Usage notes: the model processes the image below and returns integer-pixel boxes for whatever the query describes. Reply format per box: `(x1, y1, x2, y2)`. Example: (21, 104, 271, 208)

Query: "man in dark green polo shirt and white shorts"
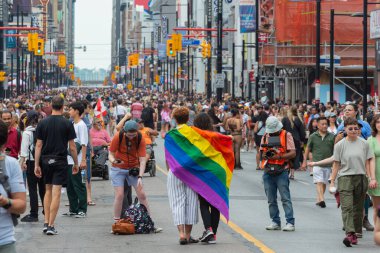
(302, 117, 335, 208)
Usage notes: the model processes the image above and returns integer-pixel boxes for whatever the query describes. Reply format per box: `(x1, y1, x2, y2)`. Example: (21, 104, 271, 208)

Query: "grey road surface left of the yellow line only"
(16, 171, 260, 253)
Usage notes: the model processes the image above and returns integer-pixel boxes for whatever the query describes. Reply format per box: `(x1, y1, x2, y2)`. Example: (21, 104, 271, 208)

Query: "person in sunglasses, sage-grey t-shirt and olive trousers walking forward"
(330, 117, 377, 247)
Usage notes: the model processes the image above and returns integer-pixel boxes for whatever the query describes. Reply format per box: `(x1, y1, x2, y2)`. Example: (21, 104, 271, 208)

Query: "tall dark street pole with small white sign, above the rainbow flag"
(216, 0, 224, 101)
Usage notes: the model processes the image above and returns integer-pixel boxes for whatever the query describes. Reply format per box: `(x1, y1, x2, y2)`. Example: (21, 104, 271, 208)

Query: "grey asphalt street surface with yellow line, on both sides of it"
(16, 139, 376, 253)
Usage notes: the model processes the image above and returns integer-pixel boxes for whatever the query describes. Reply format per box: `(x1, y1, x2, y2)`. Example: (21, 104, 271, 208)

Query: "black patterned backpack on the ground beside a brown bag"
(121, 197, 154, 234)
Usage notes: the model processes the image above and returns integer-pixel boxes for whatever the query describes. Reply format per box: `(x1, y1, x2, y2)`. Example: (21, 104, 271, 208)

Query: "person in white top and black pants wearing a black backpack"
(20, 111, 45, 222)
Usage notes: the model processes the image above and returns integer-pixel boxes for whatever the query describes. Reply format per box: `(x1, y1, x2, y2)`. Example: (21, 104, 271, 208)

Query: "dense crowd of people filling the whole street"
(0, 88, 380, 252)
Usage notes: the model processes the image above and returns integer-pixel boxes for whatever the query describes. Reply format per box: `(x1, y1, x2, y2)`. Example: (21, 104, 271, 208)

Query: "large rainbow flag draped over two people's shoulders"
(165, 125, 235, 220)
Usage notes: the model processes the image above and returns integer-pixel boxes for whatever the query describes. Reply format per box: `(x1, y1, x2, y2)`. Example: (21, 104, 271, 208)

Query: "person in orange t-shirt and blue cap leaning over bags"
(109, 120, 162, 233)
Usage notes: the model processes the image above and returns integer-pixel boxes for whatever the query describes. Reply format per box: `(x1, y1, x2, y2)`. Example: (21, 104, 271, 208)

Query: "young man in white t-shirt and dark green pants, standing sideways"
(63, 102, 88, 218)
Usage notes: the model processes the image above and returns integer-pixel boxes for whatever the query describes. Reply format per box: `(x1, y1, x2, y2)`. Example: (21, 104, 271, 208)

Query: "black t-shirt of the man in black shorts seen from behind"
(36, 115, 76, 157)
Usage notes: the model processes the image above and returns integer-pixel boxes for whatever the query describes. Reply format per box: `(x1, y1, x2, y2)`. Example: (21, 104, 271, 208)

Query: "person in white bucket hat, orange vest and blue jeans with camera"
(260, 116, 296, 231)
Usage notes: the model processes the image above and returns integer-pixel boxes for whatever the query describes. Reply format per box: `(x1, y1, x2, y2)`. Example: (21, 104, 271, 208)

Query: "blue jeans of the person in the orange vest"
(263, 171, 294, 225)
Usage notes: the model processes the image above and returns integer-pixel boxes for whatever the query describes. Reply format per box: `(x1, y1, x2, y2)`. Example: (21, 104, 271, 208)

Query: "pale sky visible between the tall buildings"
(75, 0, 112, 69)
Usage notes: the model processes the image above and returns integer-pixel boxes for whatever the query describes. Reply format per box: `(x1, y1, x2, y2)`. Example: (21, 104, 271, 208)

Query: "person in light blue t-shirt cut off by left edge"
(0, 121, 26, 253)
